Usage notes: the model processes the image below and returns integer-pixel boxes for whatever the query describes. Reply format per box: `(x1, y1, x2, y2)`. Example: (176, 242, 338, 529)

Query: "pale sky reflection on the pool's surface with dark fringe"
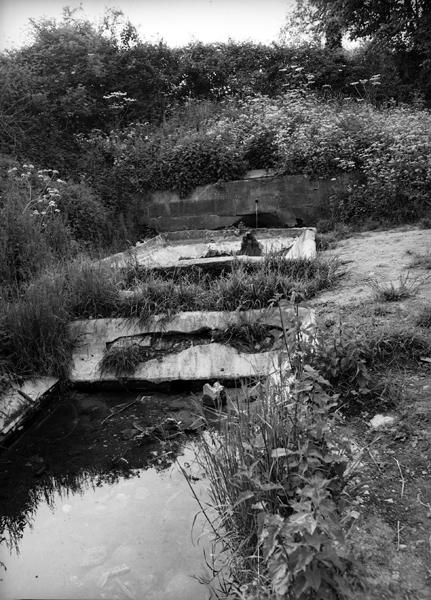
(0, 398, 213, 600)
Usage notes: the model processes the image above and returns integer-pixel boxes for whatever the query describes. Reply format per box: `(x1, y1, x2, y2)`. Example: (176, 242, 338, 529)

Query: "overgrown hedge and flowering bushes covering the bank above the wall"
(0, 6, 431, 237)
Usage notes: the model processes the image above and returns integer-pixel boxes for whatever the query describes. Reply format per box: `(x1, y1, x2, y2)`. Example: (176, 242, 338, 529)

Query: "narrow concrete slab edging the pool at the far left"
(0, 377, 58, 436)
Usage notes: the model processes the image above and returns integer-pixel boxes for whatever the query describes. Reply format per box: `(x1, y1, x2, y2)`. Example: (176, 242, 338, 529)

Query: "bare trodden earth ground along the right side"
(313, 227, 431, 600)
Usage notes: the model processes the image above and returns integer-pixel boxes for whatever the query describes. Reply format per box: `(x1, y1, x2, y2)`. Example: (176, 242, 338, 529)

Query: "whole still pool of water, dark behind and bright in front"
(0, 395, 213, 600)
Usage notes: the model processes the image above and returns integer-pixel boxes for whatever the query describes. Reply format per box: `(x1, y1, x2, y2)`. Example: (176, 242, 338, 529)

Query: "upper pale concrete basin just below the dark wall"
(101, 228, 316, 269)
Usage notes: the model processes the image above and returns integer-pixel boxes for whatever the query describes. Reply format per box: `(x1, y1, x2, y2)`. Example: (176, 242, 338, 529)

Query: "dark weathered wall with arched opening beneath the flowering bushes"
(142, 171, 350, 231)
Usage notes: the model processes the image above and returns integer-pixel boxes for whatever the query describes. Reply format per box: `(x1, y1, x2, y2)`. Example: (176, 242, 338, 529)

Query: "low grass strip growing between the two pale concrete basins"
(117, 256, 341, 319)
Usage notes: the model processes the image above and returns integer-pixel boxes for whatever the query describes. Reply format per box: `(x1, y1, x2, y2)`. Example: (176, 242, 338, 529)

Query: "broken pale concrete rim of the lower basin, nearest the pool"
(70, 308, 314, 384)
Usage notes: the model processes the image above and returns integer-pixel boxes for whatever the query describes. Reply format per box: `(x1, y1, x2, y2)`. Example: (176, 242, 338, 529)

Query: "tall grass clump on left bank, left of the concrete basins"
(0, 258, 119, 379)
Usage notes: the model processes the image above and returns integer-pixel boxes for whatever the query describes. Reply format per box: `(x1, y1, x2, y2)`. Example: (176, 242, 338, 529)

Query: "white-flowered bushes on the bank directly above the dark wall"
(76, 91, 431, 223)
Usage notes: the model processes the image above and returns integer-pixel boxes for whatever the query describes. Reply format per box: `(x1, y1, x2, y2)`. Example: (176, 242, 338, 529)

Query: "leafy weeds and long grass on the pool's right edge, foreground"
(189, 312, 354, 600)
